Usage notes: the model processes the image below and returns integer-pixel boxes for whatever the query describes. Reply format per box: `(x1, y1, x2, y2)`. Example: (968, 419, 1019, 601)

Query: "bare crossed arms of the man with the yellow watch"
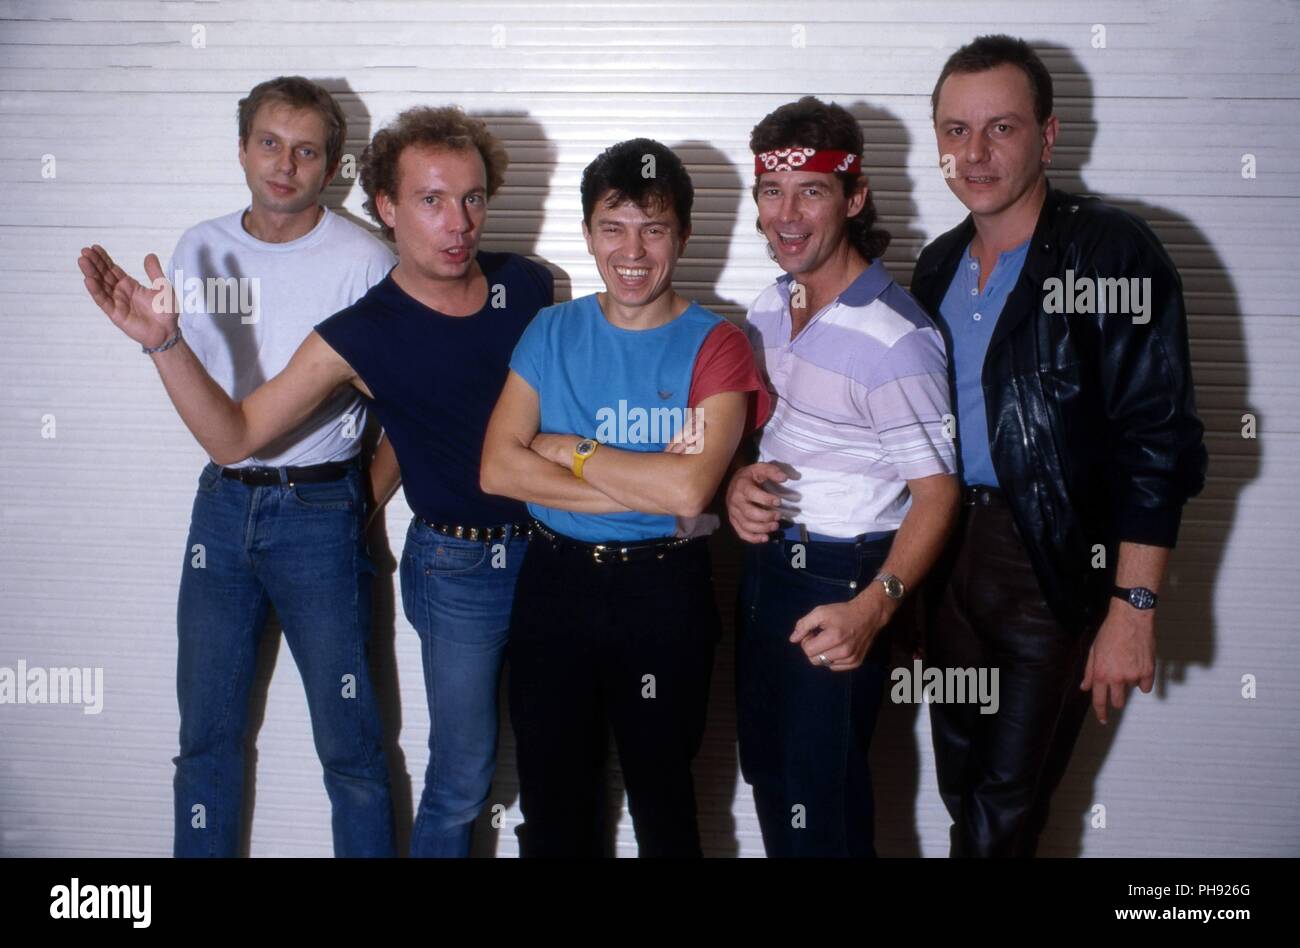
(480, 371, 748, 518)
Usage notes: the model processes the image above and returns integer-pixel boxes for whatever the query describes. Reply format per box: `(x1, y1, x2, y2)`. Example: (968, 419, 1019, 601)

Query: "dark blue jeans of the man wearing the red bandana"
(736, 534, 893, 857)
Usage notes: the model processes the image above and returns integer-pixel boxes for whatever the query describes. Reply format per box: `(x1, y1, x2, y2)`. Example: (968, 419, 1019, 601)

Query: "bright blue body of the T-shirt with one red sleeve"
(510, 294, 723, 542)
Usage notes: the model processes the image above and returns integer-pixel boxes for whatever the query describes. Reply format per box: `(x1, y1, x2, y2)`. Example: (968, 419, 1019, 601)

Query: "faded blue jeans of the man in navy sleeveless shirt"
(402, 518, 528, 858)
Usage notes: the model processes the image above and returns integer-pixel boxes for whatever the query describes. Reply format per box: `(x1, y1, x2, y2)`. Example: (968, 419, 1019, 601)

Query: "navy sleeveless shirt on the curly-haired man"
(316, 251, 555, 527)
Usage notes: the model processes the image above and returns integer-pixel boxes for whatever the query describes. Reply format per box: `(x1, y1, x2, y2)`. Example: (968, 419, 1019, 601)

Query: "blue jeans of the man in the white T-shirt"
(174, 463, 397, 856)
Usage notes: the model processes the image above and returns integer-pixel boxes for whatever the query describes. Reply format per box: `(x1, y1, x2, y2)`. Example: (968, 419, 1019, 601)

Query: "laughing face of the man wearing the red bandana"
(755, 172, 867, 276)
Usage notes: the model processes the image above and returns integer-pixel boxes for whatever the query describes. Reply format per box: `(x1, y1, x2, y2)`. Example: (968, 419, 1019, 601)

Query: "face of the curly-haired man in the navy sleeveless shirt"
(374, 144, 488, 280)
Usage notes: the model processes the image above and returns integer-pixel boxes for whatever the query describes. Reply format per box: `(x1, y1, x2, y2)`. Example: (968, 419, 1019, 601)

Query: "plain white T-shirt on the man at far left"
(165, 208, 397, 467)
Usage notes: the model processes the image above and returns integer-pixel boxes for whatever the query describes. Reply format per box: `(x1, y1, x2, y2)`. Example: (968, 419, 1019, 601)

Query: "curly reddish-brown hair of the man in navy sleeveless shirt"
(360, 105, 510, 241)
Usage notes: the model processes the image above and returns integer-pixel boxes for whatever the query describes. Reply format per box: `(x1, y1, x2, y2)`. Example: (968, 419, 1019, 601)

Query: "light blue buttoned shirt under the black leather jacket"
(939, 241, 1030, 488)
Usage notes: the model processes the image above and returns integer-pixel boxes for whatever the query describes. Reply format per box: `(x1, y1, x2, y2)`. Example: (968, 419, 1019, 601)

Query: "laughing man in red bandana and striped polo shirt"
(727, 96, 957, 857)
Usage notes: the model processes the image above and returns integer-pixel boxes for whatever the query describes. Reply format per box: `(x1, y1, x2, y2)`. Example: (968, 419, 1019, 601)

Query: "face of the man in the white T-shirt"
(239, 101, 334, 215)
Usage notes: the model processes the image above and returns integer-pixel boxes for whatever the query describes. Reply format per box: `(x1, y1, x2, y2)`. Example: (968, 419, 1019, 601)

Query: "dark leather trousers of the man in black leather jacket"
(926, 501, 1096, 857)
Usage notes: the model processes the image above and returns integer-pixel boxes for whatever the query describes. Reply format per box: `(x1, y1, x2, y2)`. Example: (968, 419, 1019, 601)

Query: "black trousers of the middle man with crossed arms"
(507, 536, 722, 857)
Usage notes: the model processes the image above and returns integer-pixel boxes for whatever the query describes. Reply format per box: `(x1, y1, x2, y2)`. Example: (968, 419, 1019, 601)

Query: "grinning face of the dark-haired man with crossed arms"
(582, 191, 690, 311)
